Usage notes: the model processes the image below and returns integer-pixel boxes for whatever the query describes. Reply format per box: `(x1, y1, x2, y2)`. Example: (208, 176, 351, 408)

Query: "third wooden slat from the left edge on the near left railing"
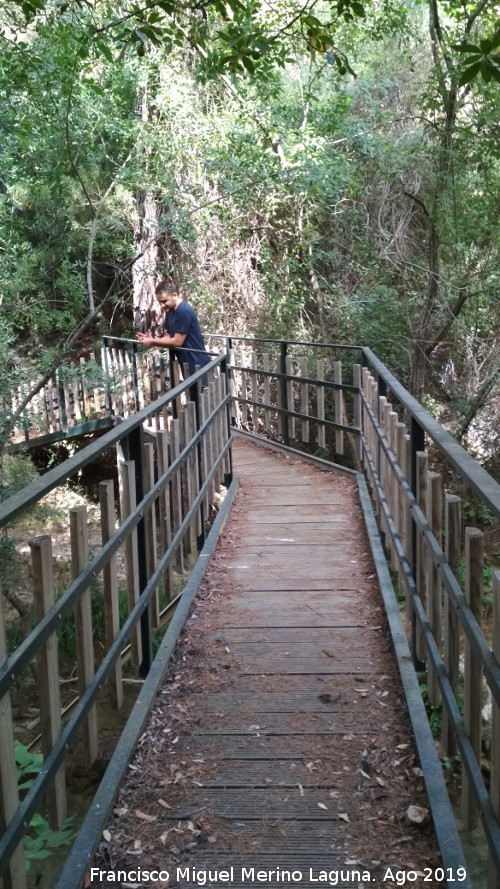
(69, 506, 99, 764)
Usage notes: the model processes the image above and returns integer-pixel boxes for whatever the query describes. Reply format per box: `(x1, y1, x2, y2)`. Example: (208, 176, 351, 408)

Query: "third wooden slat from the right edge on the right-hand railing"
(442, 494, 462, 756)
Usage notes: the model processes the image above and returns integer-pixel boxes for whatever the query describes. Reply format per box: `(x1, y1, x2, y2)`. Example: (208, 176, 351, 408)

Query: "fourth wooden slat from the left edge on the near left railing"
(99, 480, 123, 710)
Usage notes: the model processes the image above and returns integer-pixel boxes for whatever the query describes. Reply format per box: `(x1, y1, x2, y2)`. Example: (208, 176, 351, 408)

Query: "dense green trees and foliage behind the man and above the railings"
(0, 0, 500, 458)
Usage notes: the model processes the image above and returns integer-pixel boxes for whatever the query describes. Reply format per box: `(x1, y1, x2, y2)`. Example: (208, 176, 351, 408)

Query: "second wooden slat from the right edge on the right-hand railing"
(462, 528, 484, 830)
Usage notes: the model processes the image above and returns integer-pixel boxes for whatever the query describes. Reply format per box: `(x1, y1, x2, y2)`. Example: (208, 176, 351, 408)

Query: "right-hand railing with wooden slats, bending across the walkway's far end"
(221, 338, 500, 889)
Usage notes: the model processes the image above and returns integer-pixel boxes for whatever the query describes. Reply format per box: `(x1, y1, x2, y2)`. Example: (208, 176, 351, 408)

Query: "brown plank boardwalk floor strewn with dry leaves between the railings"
(99, 440, 441, 889)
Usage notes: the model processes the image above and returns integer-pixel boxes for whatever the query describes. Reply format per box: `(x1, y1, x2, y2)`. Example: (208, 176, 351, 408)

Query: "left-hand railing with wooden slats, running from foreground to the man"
(0, 355, 231, 889)
